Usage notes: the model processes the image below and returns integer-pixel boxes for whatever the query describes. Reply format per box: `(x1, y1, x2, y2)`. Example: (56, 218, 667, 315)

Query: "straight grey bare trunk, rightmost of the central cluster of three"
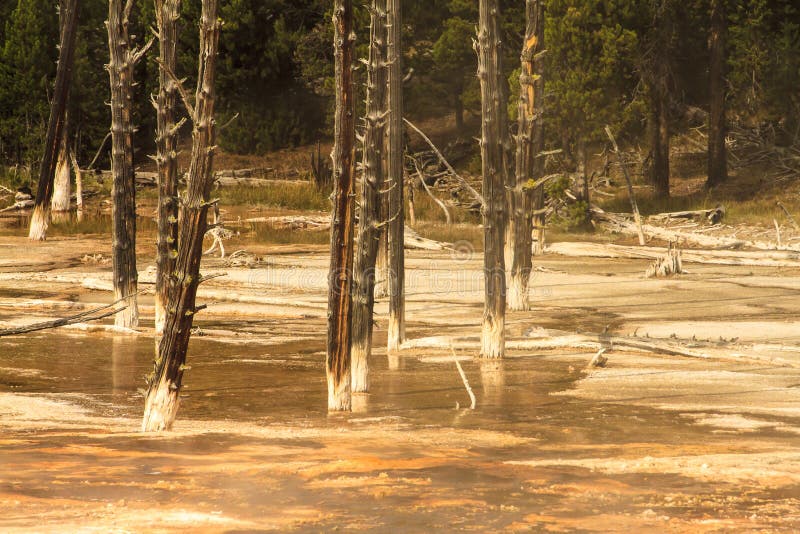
(386, 0, 406, 351)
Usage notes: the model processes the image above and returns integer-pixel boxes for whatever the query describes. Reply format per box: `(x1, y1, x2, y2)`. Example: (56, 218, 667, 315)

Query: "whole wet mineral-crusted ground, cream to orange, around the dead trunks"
(0, 216, 800, 532)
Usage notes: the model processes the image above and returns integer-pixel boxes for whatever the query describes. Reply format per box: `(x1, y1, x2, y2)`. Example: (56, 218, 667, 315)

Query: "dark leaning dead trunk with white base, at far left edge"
(28, 0, 78, 241)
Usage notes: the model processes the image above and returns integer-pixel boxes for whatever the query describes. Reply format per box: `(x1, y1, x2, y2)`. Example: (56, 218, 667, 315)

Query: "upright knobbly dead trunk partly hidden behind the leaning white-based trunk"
(155, 0, 181, 339)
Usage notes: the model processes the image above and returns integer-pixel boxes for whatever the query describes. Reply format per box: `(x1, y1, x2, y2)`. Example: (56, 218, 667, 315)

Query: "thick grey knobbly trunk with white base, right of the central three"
(477, 0, 507, 358)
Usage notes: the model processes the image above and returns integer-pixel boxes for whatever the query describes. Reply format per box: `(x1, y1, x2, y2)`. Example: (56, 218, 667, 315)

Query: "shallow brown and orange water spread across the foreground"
(0, 330, 800, 531)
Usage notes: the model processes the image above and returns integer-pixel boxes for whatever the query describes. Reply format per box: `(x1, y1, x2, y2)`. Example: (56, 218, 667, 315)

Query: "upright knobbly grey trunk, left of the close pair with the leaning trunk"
(107, 0, 139, 328)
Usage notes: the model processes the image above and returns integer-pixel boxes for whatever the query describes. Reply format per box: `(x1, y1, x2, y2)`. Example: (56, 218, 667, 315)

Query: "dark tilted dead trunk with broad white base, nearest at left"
(142, 0, 220, 432)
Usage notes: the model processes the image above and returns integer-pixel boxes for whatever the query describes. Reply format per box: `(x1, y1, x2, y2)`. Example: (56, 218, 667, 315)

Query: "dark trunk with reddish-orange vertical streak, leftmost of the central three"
(325, 0, 356, 411)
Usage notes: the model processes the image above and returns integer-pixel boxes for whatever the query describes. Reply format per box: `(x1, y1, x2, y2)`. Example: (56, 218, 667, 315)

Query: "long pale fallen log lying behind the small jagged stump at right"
(545, 242, 800, 267)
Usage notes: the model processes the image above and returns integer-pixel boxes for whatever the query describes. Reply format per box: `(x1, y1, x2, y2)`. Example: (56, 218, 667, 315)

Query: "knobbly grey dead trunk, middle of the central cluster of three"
(350, 0, 386, 393)
